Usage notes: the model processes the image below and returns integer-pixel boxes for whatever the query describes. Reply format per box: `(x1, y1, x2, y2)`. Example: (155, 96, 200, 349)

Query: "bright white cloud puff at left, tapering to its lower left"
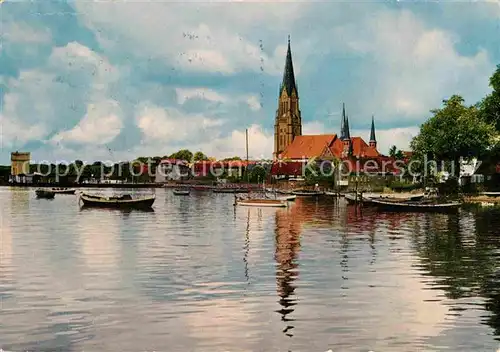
(51, 100, 123, 145)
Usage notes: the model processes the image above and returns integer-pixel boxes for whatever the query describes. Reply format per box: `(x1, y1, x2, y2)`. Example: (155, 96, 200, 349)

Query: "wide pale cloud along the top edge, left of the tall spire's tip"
(75, 0, 303, 75)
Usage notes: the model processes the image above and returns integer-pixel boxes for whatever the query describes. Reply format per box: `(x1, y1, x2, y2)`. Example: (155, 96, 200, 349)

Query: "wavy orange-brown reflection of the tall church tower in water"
(275, 206, 302, 337)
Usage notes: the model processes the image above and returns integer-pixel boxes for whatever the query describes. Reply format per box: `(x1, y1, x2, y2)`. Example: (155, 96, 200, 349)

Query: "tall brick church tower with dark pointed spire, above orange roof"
(273, 36, 302, 160)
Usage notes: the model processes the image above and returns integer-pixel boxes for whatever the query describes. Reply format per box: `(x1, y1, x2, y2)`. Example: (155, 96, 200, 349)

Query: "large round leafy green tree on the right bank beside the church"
(411, 95, 495, 177)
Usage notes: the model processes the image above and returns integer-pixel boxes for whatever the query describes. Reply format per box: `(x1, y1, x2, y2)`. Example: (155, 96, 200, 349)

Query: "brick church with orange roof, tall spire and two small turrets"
(273, 37, 384, 162)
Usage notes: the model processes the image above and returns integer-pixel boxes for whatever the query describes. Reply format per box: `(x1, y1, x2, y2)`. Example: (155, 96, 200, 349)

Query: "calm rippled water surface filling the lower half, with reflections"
(0, 188, 500, 352)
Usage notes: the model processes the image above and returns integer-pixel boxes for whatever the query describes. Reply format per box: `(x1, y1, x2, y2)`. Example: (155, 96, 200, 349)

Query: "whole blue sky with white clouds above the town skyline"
(0, 0, 500, 164)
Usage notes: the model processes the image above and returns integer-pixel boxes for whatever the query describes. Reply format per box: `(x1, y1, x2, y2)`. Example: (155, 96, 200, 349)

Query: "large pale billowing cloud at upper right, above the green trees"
(334, 10, 494, 116)
